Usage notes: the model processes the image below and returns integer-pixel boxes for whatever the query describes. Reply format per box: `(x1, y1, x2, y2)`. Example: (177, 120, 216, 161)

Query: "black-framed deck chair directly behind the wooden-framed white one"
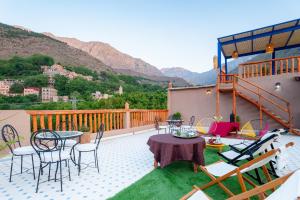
(218, 132, 280, 183)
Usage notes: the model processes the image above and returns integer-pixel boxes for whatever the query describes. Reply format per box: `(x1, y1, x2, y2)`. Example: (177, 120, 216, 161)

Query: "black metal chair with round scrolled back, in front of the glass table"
(30, 129, 71, 193)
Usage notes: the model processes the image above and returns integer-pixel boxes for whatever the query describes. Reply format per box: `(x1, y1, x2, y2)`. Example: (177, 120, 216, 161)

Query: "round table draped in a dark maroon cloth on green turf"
(147, 134, 205, 172)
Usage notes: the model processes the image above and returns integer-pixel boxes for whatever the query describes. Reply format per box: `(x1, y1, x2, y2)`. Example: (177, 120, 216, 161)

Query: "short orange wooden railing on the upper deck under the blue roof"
(239, 56, 300, 78)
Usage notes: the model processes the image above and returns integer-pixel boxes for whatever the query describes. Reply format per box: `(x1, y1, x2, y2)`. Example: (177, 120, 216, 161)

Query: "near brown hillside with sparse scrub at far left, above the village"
(0, 23, 112, 71)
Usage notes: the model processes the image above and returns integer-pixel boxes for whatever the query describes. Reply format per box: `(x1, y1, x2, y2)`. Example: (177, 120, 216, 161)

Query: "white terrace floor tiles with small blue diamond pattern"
(0, 131, 300, 200)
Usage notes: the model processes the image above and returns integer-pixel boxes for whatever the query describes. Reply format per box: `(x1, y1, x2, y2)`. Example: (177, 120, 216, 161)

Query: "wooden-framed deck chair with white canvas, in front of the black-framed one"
(181, 142, 294, 200)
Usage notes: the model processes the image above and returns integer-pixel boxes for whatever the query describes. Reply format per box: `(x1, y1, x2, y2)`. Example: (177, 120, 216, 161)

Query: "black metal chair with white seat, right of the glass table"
(71, 123, 104, 176)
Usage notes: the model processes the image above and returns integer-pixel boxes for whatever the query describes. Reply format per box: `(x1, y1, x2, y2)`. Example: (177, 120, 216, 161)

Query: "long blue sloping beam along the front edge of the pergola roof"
(221, 25, 300, 45)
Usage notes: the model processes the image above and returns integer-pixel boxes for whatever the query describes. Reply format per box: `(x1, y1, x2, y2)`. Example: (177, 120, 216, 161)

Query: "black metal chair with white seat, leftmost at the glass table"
(1, 124, 35, 182)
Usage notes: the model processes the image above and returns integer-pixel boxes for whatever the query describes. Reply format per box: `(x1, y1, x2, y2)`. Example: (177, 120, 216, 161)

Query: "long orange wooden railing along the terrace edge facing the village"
(27, 109, 168, 132)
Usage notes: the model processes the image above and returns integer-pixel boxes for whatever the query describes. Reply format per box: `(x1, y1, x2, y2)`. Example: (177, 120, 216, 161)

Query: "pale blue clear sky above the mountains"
(0, 0, 300, 72)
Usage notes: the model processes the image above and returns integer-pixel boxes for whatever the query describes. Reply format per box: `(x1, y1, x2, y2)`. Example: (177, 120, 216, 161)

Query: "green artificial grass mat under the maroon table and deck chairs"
(110, 148, 270, 200)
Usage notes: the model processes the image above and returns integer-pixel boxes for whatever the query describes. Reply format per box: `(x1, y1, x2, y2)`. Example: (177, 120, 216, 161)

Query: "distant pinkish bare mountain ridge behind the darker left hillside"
(44, 33, 163, 76)
